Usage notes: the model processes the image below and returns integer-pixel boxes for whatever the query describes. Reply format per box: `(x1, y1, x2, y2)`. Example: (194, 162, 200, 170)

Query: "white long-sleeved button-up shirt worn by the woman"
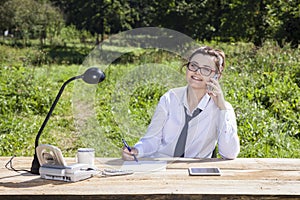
(134, 86, 240, 159)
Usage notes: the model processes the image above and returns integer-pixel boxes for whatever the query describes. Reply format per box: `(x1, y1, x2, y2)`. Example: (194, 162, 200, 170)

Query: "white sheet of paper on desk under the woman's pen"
(121, 160, 167, 172)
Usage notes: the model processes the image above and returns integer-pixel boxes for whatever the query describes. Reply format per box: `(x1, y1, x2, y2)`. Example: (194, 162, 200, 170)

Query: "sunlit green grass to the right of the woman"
(222, 43, 300, 157)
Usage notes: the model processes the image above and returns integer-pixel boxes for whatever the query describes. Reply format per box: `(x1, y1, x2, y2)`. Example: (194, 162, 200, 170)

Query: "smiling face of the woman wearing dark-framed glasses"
(186, 53, 216, 90)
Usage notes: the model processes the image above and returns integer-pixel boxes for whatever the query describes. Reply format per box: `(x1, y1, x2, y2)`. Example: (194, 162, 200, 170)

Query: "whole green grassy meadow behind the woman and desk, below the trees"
(0, 42, 300, 158)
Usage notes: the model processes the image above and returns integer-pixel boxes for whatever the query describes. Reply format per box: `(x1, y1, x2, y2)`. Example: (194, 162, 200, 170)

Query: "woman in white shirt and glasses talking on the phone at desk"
(122, 47, 240, 160)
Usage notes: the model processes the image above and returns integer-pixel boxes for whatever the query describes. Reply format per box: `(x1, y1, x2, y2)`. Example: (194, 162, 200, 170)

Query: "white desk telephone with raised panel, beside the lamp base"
(36, 144, 99, 182)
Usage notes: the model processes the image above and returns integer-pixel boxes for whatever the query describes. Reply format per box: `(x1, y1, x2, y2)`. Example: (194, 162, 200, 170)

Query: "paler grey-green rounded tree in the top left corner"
(0, 0, 63, 45)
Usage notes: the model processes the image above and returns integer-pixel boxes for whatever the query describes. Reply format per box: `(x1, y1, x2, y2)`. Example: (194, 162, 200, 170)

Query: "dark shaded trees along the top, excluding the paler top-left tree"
(40, 0, 300, 46)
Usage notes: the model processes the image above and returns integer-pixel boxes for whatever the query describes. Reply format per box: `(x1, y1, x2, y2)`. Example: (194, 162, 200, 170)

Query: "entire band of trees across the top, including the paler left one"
(0, 0, 300, 48)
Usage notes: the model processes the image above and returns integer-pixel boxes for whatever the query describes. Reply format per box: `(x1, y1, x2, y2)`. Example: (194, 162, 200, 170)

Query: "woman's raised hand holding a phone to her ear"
(206, 78, 226, 110)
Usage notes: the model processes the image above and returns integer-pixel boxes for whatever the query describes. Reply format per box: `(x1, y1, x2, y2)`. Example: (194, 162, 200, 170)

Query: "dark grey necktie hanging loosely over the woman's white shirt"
(174, 107, 202, 157)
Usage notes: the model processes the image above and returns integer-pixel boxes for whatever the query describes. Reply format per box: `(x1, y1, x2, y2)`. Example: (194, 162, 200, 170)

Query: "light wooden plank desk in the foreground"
(0, 157, 300, 199)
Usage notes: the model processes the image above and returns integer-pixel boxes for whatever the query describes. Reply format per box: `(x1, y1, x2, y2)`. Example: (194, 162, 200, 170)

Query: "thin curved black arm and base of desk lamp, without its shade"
(31, 75, 82, 174)
